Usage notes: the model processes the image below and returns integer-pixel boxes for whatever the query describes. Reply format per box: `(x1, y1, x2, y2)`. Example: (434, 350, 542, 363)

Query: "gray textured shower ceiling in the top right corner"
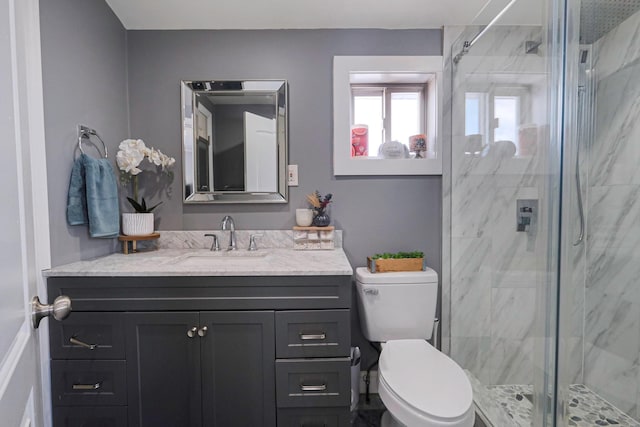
(580, 0, 640, 44)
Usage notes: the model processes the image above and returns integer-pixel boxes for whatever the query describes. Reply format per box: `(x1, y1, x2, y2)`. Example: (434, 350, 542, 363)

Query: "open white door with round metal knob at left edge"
(0, 0, 50, 427)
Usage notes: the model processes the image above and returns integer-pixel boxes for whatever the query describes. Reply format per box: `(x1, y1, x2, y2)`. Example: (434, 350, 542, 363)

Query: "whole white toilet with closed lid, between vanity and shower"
(356, 267, 475, 427)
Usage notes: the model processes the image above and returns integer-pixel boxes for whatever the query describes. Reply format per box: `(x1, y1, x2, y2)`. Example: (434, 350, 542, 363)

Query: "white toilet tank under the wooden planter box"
(356, 267, 438, 342)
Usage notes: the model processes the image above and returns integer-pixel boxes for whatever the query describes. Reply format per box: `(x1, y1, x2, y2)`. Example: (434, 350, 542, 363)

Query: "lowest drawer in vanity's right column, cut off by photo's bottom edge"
(278, 407, 351, 427)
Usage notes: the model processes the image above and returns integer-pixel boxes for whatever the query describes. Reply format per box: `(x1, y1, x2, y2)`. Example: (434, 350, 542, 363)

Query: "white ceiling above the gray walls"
(105, 0, 544, 30)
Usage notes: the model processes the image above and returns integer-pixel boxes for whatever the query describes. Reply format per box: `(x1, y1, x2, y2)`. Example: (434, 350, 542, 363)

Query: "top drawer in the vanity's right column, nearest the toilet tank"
(276, 310, 351, 358)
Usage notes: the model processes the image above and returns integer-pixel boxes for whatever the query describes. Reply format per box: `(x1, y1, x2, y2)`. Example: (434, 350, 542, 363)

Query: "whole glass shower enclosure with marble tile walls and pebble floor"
(442, 0, 640, 427)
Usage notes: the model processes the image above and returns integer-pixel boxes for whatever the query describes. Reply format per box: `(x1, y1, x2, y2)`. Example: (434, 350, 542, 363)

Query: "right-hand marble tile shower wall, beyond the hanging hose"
(584, 8, 640, 419)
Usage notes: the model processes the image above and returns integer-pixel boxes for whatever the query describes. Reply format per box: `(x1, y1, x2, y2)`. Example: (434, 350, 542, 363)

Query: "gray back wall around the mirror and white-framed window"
(128, 30, 442, 366)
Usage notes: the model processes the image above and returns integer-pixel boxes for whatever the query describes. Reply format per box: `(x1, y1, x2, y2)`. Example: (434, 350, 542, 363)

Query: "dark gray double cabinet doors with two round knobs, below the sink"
(125, 311, 275, 427)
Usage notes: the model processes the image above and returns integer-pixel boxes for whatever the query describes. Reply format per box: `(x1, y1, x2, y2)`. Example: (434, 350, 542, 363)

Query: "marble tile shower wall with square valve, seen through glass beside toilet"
(443, 27, 547, 384)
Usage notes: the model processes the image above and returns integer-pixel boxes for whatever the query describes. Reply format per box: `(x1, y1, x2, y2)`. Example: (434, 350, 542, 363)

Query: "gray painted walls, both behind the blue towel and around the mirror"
(41, 17, 442, 366)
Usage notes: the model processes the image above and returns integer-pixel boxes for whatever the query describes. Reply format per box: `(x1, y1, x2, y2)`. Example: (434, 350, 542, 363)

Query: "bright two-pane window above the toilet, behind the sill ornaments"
(351, 84, 426, 157)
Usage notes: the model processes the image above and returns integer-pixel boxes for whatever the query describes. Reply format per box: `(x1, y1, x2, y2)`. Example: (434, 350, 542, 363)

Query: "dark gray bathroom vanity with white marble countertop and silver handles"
(47, 244, 352, 427)
